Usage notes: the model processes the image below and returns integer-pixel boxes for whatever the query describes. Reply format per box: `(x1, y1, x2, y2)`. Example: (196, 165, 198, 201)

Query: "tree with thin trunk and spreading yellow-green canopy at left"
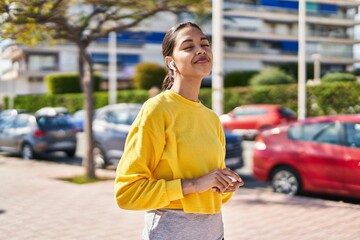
(0, 0, 209, 178)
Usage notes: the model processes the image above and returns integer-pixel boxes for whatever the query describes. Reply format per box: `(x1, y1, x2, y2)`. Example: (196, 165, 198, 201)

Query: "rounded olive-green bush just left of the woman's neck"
(133, 63, 166, 90)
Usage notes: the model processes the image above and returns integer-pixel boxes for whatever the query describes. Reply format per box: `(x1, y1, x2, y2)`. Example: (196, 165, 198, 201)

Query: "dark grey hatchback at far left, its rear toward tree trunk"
(0, 109, 77, 159)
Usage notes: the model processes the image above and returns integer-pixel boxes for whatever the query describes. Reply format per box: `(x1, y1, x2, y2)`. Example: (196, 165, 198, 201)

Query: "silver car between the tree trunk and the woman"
(93, 103, 142, 168)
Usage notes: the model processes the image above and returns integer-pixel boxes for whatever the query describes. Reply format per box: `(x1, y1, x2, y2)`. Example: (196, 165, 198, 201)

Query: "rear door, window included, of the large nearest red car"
(301, 122, 345, 191)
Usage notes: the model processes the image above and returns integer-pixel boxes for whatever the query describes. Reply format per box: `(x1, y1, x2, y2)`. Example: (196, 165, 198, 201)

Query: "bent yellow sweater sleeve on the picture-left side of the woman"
(115, 107, 183, 210)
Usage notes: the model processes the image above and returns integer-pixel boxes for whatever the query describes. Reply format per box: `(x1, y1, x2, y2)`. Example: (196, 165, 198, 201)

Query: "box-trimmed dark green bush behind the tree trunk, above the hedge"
(45, 73, 101, 94)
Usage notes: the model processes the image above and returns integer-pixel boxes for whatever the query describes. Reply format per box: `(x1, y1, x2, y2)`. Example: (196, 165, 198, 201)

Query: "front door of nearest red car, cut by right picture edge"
(343, 122, 360, 196)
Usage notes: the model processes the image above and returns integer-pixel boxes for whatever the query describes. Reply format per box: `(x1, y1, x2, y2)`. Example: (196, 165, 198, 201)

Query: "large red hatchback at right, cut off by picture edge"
(253, 115, 360, 198)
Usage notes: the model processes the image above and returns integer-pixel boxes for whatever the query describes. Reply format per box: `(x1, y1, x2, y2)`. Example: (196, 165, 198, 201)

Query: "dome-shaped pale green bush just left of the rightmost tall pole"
(250, 67, 296, 86)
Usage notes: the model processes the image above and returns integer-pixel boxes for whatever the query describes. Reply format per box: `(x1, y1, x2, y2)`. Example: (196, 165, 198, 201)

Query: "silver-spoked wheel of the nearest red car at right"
(271, 167, 301, 196)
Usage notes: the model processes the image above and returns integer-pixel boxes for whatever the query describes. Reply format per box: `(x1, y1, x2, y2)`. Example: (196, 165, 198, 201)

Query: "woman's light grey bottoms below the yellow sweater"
(142, 209, 224, 240)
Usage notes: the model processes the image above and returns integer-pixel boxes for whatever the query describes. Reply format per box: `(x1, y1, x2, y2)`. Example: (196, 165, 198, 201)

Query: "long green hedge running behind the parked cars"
(4, 82, 360, 116)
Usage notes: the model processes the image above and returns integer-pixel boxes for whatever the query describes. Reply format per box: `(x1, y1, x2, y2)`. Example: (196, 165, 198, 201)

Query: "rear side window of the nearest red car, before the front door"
(288, 122, 340, 144)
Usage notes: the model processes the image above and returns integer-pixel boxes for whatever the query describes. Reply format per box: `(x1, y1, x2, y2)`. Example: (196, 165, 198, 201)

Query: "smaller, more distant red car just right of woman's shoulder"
(220, 104, 296, 139)
